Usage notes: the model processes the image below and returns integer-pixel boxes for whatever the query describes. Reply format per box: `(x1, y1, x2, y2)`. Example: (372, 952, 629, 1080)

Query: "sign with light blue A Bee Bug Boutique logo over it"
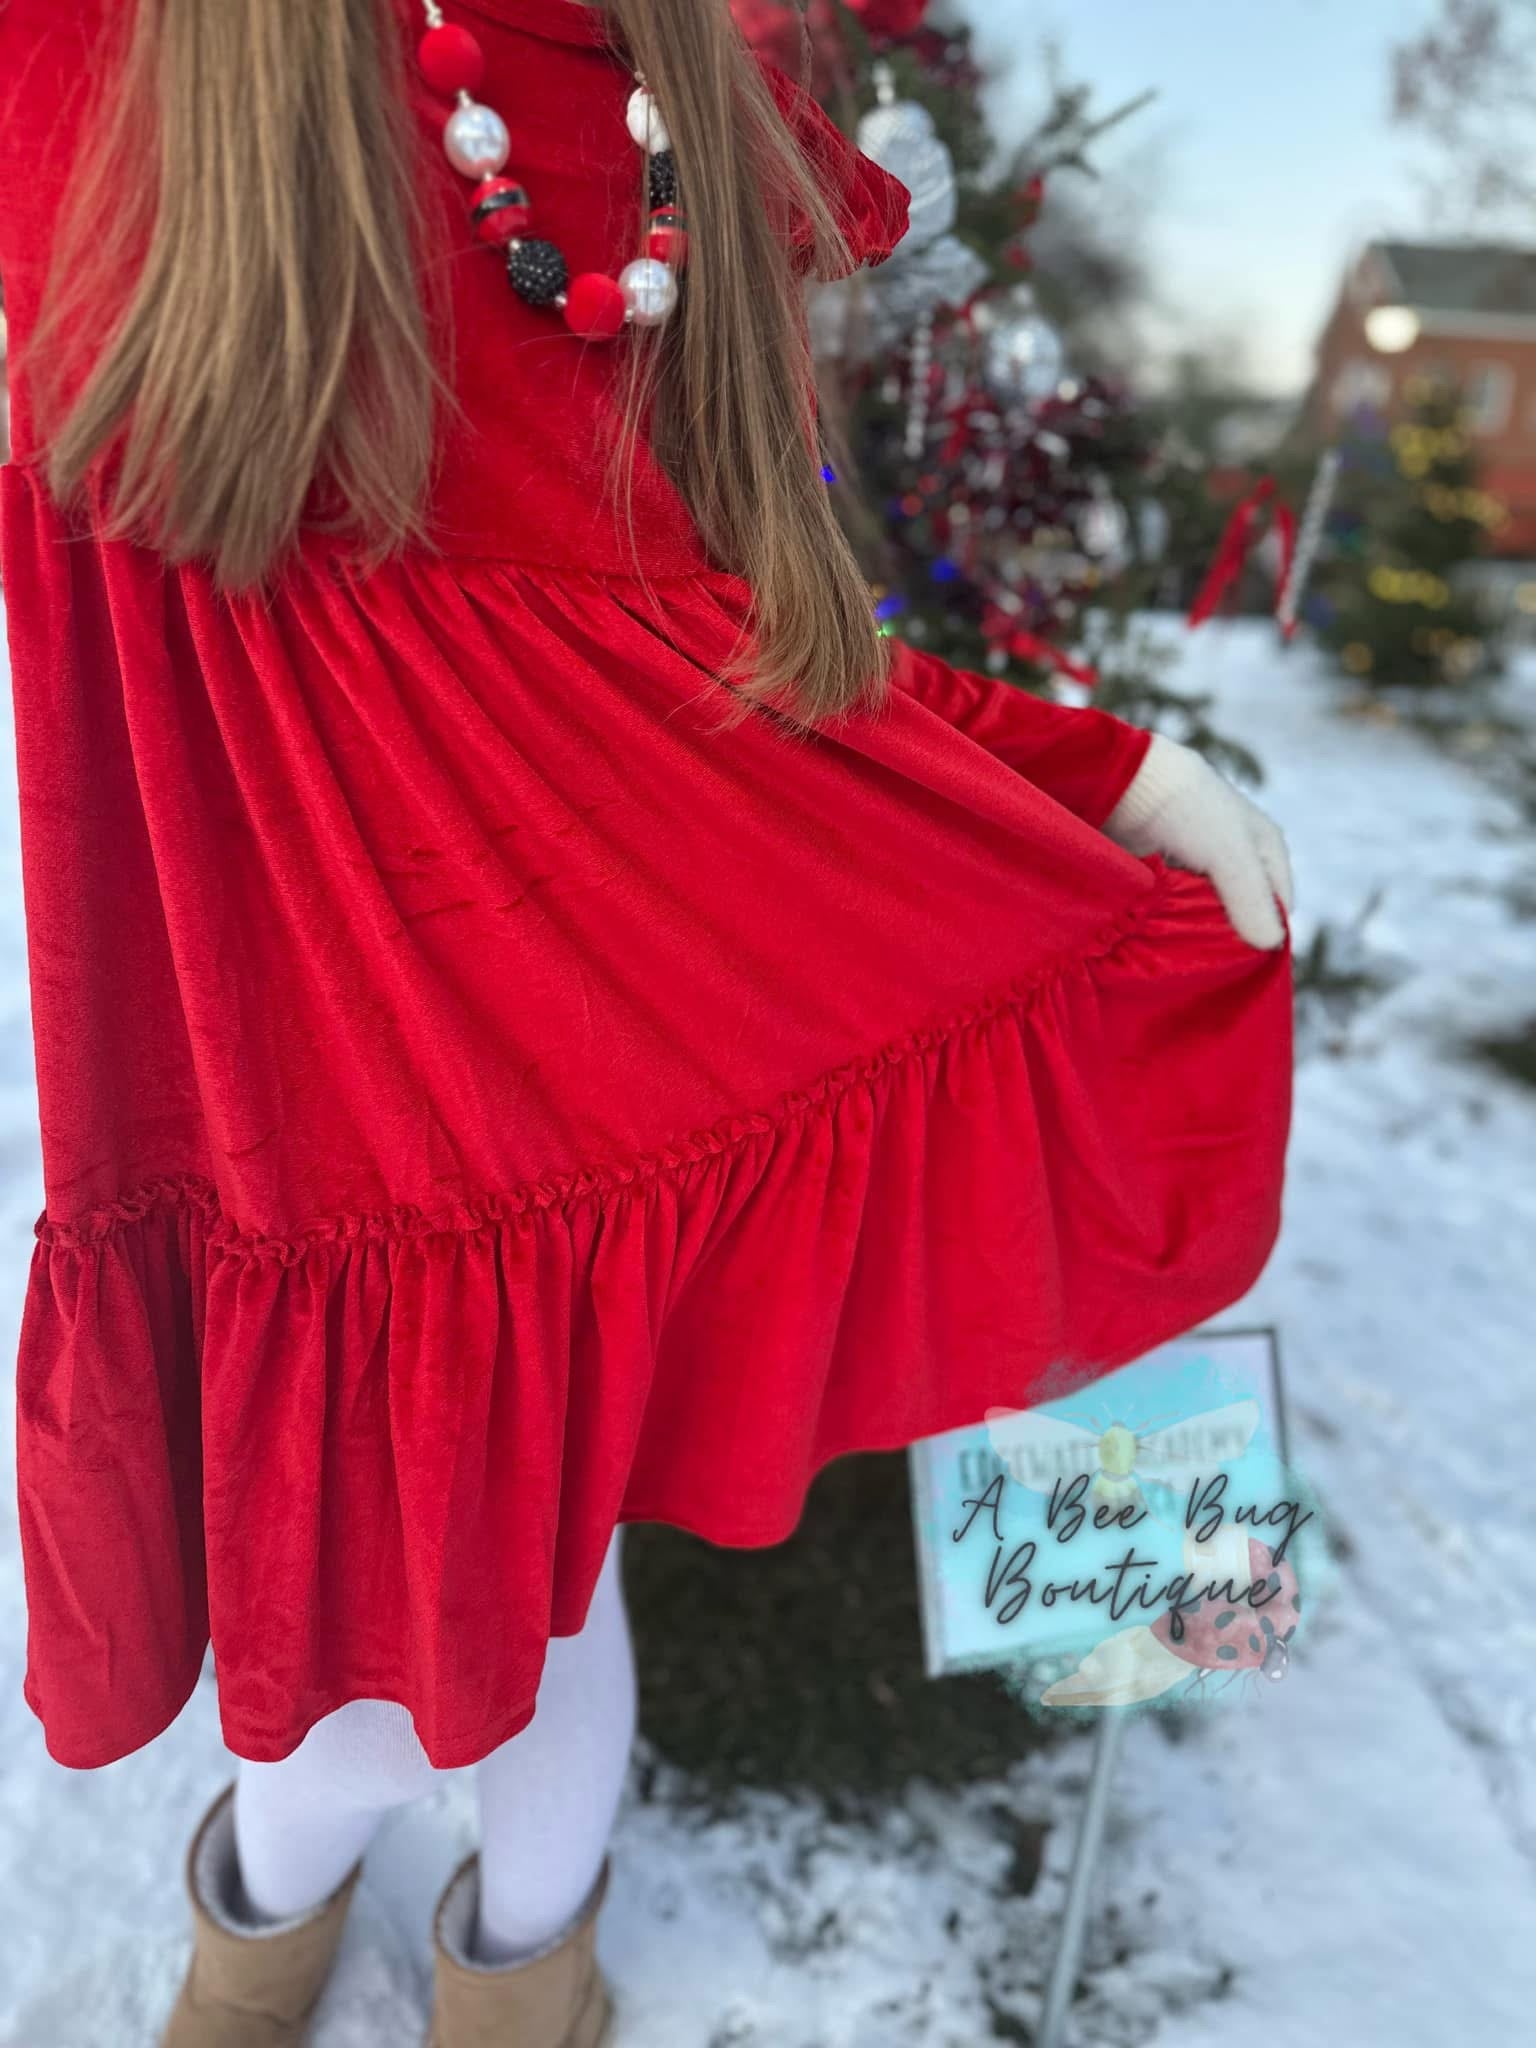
(911, 1329, 1315, 1708)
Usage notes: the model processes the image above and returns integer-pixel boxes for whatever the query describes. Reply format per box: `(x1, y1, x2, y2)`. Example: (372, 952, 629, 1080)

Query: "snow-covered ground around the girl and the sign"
(0, 627, 1536, 2048)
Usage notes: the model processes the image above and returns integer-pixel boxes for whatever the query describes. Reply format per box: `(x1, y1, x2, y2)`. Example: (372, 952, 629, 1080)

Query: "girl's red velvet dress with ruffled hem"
(0, 0, 1290, 1765)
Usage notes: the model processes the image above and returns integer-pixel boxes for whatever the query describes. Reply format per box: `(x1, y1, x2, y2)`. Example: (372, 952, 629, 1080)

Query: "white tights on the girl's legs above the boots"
(236, 1532, 635, 1962)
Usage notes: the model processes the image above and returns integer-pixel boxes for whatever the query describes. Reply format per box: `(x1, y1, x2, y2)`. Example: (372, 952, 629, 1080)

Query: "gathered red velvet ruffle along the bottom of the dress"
(20, 870, 1288, 1767)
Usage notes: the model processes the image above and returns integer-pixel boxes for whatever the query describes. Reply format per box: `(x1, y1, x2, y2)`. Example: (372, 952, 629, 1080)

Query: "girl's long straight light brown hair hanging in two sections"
(31, 0, 885, 723)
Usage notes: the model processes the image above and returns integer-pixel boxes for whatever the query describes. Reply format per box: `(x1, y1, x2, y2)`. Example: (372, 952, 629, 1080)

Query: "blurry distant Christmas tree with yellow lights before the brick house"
(1315, 379, 1505, 688)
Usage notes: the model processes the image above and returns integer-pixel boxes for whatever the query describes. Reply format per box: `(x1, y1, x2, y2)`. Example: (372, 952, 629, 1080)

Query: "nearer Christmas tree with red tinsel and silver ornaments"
(737, 0, 1253, 772)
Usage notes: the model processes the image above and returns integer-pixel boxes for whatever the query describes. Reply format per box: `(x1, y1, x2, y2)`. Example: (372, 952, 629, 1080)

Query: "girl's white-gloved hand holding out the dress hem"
(1104, 733, 1296, 952)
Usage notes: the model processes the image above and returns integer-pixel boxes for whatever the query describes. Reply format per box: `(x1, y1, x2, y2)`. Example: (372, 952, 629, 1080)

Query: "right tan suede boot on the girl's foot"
(428, 1855, 612, 2048)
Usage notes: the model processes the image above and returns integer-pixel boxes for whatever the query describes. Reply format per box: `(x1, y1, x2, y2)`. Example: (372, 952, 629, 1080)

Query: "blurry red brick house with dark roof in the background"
(1307, 242, 1536, 561)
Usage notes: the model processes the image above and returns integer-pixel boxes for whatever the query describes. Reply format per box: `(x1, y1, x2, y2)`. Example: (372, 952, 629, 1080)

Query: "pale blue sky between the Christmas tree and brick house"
(961, 0, 1444, 389)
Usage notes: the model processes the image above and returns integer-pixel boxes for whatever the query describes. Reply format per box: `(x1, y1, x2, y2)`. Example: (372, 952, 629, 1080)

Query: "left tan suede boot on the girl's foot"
(162, 1786, 362, 2048)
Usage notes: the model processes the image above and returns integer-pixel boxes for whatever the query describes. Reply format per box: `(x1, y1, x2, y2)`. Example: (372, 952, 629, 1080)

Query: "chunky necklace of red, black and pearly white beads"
(416, 0, 688, 342)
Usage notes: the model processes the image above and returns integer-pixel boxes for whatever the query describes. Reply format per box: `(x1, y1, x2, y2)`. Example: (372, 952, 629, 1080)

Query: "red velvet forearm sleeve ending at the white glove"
(891, 643, 1151, 827)
